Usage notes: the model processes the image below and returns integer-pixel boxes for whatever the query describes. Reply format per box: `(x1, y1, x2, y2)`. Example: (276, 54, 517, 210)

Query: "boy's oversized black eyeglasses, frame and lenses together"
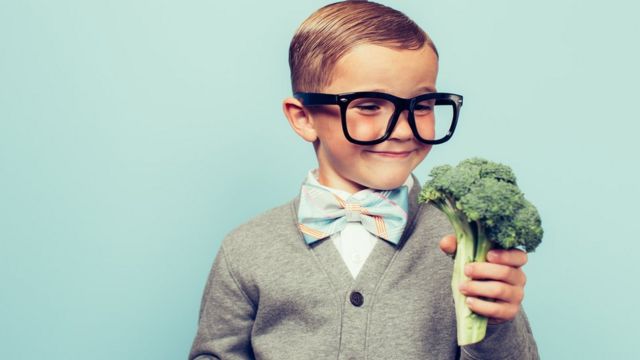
(293, 91, 462, 145)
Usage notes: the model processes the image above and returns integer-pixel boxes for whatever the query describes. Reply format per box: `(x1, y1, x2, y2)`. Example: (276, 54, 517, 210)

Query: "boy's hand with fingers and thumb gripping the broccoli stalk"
(440, 235, 527, 324)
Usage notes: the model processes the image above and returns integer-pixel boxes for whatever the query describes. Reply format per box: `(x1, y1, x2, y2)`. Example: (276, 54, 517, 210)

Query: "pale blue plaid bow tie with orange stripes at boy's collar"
(298, 181, 409, 245)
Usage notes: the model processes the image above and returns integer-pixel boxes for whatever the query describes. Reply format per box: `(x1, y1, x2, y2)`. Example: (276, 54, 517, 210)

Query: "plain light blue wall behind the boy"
(0, 0, 640, 359)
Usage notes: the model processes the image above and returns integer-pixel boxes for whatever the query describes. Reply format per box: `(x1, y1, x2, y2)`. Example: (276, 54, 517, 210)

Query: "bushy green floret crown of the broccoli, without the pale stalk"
(418, 158, 543, 251)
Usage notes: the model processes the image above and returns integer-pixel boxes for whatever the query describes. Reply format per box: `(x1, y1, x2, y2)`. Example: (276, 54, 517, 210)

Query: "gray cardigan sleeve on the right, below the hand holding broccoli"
(460, 309, 540, 360)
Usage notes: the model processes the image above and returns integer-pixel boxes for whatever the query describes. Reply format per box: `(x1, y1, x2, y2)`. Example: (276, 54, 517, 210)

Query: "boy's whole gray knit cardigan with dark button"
(189, 181, 538, 360)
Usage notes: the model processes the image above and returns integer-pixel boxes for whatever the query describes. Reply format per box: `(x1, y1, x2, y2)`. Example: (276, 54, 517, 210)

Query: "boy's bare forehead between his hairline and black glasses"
(324, 44, 438, 97)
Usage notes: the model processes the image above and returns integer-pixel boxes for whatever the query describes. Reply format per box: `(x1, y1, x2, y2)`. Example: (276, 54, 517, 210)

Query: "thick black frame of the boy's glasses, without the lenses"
(293, 91, 462, 145)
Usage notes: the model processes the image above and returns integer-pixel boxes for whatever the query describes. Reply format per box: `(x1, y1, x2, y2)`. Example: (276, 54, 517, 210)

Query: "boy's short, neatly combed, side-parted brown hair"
(289, 0, 438, 92)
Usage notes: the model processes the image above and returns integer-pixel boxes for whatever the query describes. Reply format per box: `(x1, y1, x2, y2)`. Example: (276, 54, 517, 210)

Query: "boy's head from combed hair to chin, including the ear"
(283, 1, 461, 193)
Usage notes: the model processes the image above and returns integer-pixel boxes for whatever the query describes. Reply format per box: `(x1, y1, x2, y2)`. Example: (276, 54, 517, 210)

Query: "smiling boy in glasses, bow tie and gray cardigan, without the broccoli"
(189, 1, 538, 360)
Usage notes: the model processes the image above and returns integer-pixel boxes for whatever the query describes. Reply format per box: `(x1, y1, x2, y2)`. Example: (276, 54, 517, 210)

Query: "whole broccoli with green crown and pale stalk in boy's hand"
(418, 158, 543, 346)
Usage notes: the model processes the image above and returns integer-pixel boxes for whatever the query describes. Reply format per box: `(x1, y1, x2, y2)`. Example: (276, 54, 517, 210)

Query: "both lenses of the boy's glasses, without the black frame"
(346, 98, 453, 141)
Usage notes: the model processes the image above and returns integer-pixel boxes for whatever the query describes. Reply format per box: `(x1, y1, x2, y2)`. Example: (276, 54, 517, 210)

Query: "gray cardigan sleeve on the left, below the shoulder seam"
(189, 244, 256, 360)
